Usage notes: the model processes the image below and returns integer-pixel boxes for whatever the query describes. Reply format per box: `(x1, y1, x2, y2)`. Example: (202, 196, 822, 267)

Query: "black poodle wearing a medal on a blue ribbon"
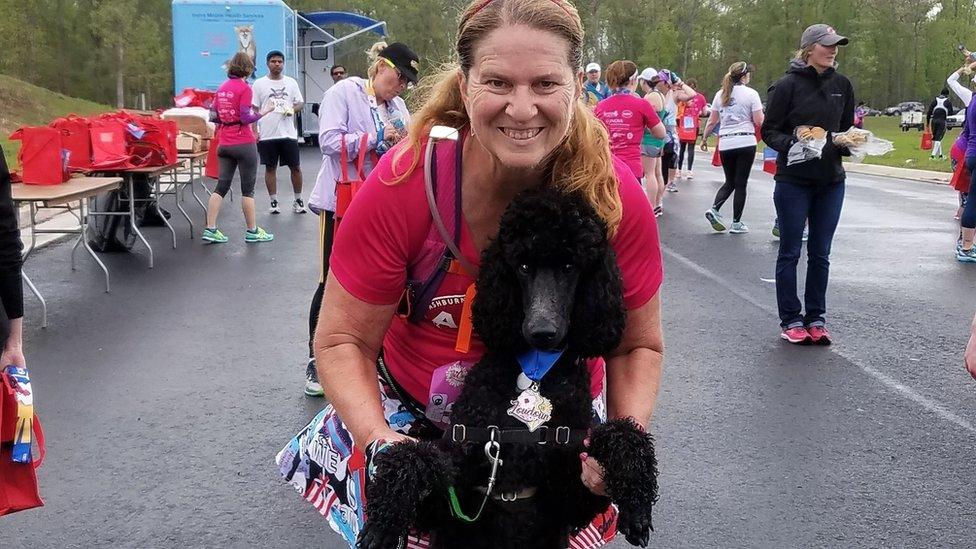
(358, 189, 657, 549)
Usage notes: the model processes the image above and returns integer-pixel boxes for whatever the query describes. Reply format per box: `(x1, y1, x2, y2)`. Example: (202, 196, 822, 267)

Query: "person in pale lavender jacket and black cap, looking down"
(305, 42, 420, 396)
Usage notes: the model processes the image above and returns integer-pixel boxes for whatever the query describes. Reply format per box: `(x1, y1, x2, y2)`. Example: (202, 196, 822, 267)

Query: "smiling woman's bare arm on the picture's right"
(607, 291, 664, 429)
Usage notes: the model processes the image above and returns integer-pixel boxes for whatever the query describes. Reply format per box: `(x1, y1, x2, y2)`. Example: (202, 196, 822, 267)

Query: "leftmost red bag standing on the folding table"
(10, 126, 71, 185)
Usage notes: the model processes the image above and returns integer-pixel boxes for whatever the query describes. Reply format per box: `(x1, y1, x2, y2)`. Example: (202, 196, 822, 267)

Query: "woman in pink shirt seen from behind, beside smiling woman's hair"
(593, 61, 666, 181)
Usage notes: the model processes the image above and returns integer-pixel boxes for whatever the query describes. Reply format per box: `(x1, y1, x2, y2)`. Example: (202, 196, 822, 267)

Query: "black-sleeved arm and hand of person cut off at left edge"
(0, 149, 26, 369)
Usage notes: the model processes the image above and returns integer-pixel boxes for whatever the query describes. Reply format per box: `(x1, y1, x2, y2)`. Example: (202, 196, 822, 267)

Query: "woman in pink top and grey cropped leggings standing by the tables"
(201, 52, 274, 243)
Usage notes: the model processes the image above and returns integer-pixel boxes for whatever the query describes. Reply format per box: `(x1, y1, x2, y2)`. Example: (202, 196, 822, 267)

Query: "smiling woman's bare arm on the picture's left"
(313, 273, 407, 448)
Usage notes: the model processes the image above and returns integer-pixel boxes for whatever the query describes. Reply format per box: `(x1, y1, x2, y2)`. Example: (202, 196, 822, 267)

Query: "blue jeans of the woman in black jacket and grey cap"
(773, 181, 844, 328)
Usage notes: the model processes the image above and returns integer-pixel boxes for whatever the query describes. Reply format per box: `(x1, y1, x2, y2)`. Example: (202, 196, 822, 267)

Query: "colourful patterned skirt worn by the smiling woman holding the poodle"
(275, 382, 617, 549)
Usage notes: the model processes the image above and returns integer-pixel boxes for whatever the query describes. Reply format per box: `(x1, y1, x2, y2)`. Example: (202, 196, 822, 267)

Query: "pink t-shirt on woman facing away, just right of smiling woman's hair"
(593, 93, 661, 179)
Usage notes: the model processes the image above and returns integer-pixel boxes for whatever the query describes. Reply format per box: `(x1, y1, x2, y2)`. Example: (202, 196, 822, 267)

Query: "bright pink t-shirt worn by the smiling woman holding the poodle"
(330, 139, 663, 408)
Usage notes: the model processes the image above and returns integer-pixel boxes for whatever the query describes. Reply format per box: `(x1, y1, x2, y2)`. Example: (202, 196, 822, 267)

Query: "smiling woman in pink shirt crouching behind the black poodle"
(278, 0, 663, 547)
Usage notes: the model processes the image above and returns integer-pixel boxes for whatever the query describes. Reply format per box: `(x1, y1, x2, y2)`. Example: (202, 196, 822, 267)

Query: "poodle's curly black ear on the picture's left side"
(471, 239, 525, 351)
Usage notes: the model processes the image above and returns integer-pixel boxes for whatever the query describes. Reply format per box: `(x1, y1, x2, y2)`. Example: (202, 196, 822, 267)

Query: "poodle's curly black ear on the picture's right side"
(568, 240, 627, 357)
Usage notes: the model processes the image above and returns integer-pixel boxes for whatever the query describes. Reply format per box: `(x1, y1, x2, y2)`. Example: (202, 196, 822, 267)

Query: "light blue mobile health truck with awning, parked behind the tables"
(173, 0, 386, 143)
